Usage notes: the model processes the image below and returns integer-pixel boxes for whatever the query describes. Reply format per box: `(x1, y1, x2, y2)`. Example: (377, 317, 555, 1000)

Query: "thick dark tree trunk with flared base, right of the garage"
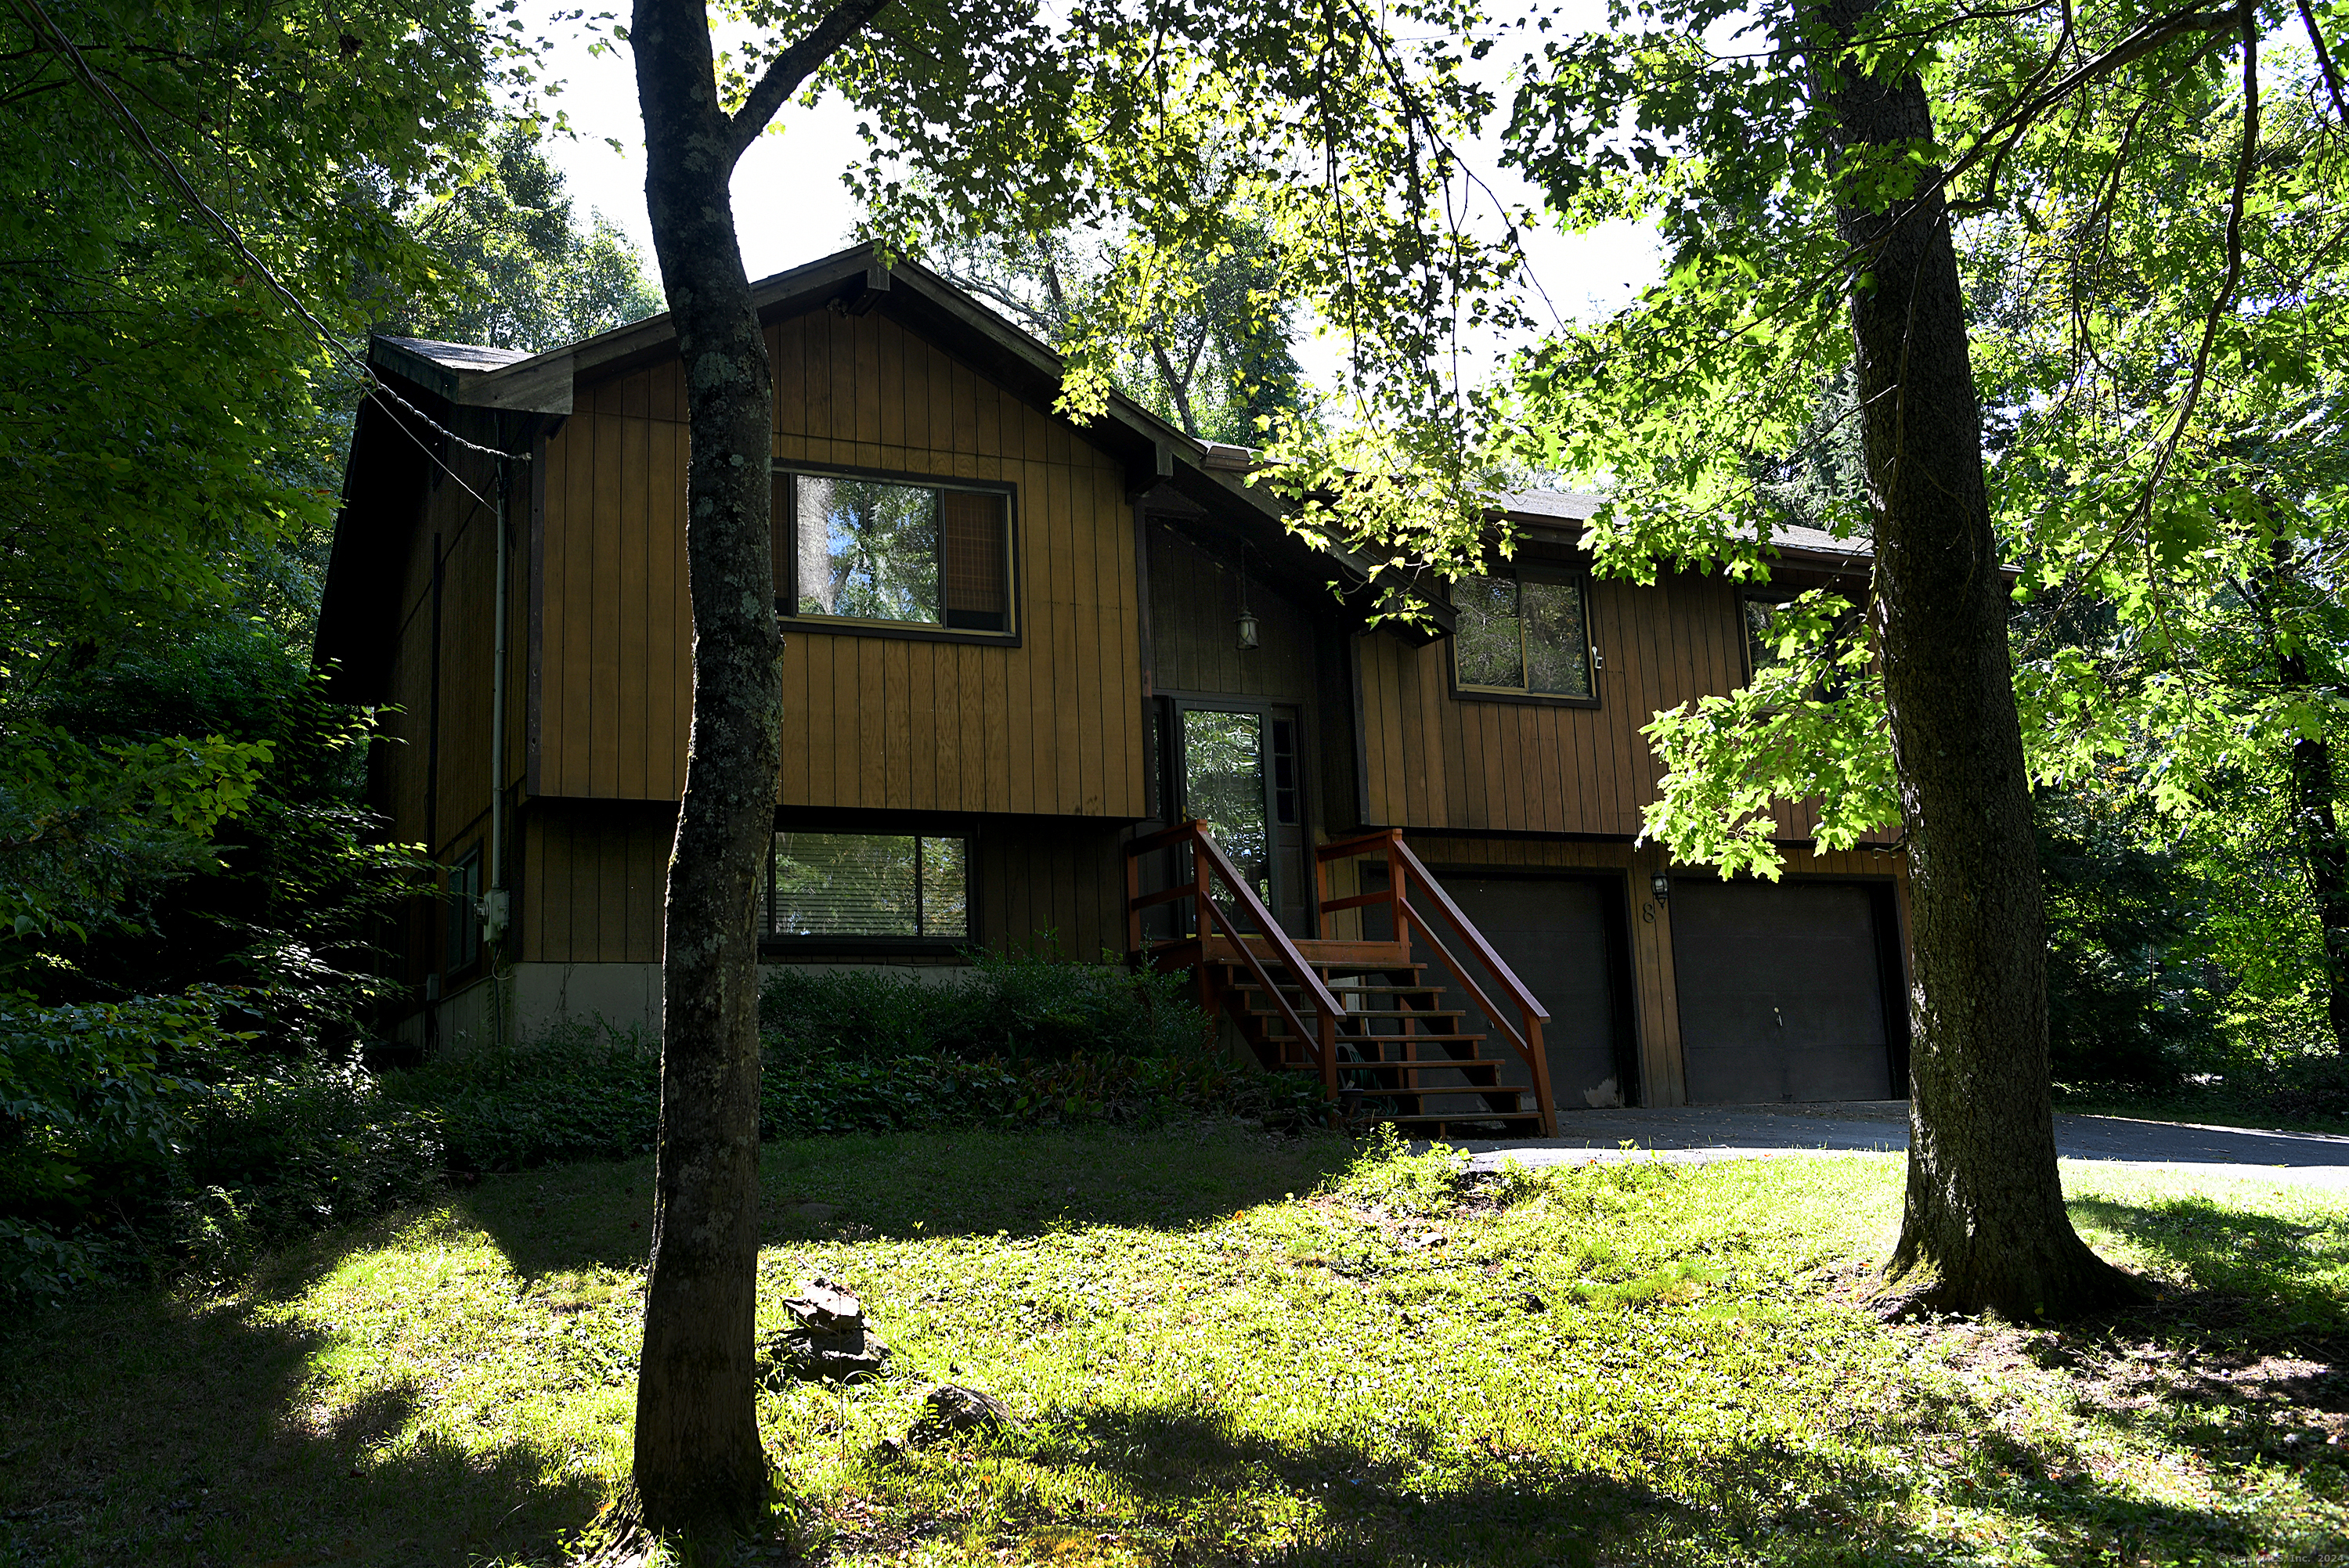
(1818, 0, 2135, 1317)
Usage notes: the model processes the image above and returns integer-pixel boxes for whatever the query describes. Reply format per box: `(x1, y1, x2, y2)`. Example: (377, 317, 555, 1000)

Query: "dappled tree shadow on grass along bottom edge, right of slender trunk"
(958, 1404, 2253, 1568)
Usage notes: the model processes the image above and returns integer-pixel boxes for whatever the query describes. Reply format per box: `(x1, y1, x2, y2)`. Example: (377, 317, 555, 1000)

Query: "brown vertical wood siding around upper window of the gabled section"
(538, 310, 1146, 816)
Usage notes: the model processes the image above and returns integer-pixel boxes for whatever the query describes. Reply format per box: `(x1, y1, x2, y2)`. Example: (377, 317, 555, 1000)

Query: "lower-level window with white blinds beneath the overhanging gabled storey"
(759, 833, 970, 939)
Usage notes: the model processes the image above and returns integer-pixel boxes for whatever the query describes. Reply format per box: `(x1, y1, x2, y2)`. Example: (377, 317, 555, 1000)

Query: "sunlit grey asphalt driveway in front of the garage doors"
(1459, 1101, 2349, 1190)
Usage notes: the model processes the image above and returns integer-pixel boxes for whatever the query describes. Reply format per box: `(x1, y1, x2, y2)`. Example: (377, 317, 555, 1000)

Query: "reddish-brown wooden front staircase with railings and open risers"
(1125, 821, 1557, 1138)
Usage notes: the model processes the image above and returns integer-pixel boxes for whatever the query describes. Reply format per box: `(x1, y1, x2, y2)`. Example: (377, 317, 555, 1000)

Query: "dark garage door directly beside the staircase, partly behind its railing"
(1435, 871, 1637, 1110)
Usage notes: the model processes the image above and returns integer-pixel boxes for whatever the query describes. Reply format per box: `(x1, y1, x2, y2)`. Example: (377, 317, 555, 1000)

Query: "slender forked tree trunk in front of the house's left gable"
(632, 0, 782, 1533)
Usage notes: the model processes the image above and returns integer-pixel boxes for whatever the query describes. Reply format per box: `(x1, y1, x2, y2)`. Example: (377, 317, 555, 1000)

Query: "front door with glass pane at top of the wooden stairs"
(1167, 702, 1313, 936)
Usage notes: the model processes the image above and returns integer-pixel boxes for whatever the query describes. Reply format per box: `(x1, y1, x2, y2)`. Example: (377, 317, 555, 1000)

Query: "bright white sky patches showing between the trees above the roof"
(524, 12, 1658, 387)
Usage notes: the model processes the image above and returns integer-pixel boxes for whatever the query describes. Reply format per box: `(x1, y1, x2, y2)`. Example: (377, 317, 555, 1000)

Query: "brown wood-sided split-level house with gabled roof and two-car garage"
(317, 249, 1907, 1124)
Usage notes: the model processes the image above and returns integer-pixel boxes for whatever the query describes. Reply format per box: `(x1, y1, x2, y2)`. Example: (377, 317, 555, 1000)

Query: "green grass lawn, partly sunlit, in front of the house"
(0, 1126, 2349, 1568)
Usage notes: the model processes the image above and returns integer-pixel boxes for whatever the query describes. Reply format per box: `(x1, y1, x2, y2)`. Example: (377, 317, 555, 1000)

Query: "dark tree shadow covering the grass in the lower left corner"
(0, 1239, 601, 1568)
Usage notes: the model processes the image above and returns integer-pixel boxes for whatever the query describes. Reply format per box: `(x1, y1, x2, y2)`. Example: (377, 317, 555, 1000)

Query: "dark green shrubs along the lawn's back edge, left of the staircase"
(0, 957, 1327, 1298)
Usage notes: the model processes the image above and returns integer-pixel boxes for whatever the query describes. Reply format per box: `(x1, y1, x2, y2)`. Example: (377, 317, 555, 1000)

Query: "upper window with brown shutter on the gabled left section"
(775, 474, 1012, 634)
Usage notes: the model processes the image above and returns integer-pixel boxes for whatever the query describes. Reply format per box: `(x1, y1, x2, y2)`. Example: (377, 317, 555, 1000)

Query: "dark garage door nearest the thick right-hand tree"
(1670, 880, 1893, 1105)
